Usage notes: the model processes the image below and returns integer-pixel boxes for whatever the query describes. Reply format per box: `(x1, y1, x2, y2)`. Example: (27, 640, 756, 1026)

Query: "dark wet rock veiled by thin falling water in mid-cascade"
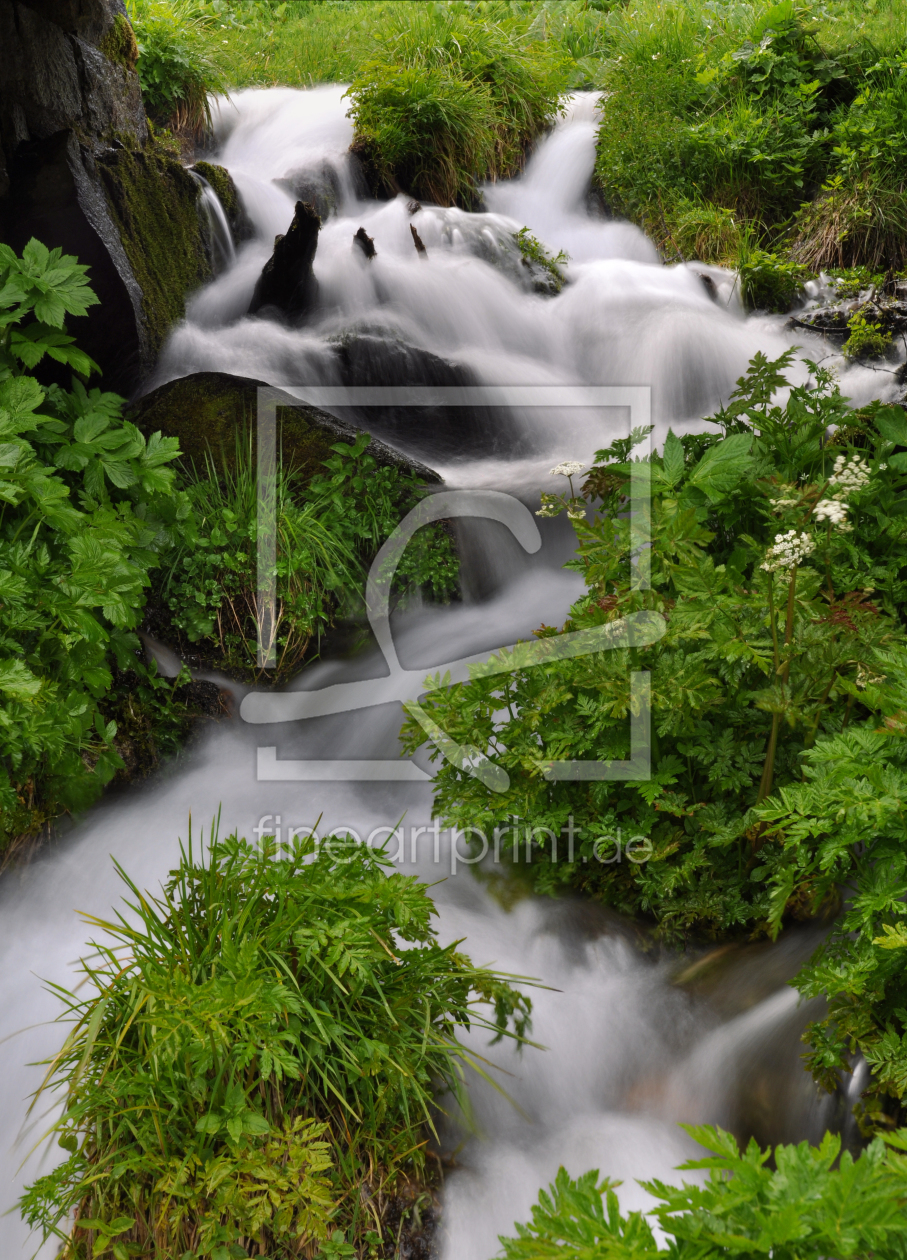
(334, 328, 528, 461)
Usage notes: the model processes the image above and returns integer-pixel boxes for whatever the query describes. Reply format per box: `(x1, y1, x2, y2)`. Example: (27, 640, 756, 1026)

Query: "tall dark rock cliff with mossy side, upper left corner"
(0, 0, 210, 393)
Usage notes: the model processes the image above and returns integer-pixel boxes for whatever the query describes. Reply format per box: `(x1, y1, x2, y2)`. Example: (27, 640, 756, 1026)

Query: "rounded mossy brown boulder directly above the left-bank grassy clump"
(127, 372, 440, 483)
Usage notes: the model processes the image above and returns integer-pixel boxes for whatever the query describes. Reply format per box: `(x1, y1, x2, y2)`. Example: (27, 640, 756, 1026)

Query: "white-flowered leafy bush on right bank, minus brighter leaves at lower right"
(404, 354, 907, 936)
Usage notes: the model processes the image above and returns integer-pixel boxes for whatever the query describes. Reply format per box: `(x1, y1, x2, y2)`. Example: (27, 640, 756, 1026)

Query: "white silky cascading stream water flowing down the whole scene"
(0, 87, 879, 1260)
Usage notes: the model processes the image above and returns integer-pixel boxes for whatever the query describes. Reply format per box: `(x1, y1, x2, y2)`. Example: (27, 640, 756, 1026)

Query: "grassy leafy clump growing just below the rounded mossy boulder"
(160, 433, 457, 678)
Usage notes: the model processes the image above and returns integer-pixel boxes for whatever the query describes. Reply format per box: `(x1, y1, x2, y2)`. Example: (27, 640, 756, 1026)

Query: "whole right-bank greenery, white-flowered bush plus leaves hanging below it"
(404, 352, 907, 1114)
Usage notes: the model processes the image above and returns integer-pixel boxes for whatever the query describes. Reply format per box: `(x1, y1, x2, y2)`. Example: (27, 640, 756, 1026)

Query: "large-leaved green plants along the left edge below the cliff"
(0, 241, 188, 842)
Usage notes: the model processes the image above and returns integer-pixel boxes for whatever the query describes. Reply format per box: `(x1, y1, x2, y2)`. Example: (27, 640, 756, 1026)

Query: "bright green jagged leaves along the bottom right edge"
(500, 1125, 907, 1260)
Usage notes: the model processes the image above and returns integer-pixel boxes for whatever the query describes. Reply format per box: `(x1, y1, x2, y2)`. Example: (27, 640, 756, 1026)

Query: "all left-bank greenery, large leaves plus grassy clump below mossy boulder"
(0, 241, 456, 849)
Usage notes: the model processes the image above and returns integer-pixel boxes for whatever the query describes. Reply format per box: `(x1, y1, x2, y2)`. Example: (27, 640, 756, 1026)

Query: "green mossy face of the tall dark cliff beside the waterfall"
(98, 146, 212, 354)
